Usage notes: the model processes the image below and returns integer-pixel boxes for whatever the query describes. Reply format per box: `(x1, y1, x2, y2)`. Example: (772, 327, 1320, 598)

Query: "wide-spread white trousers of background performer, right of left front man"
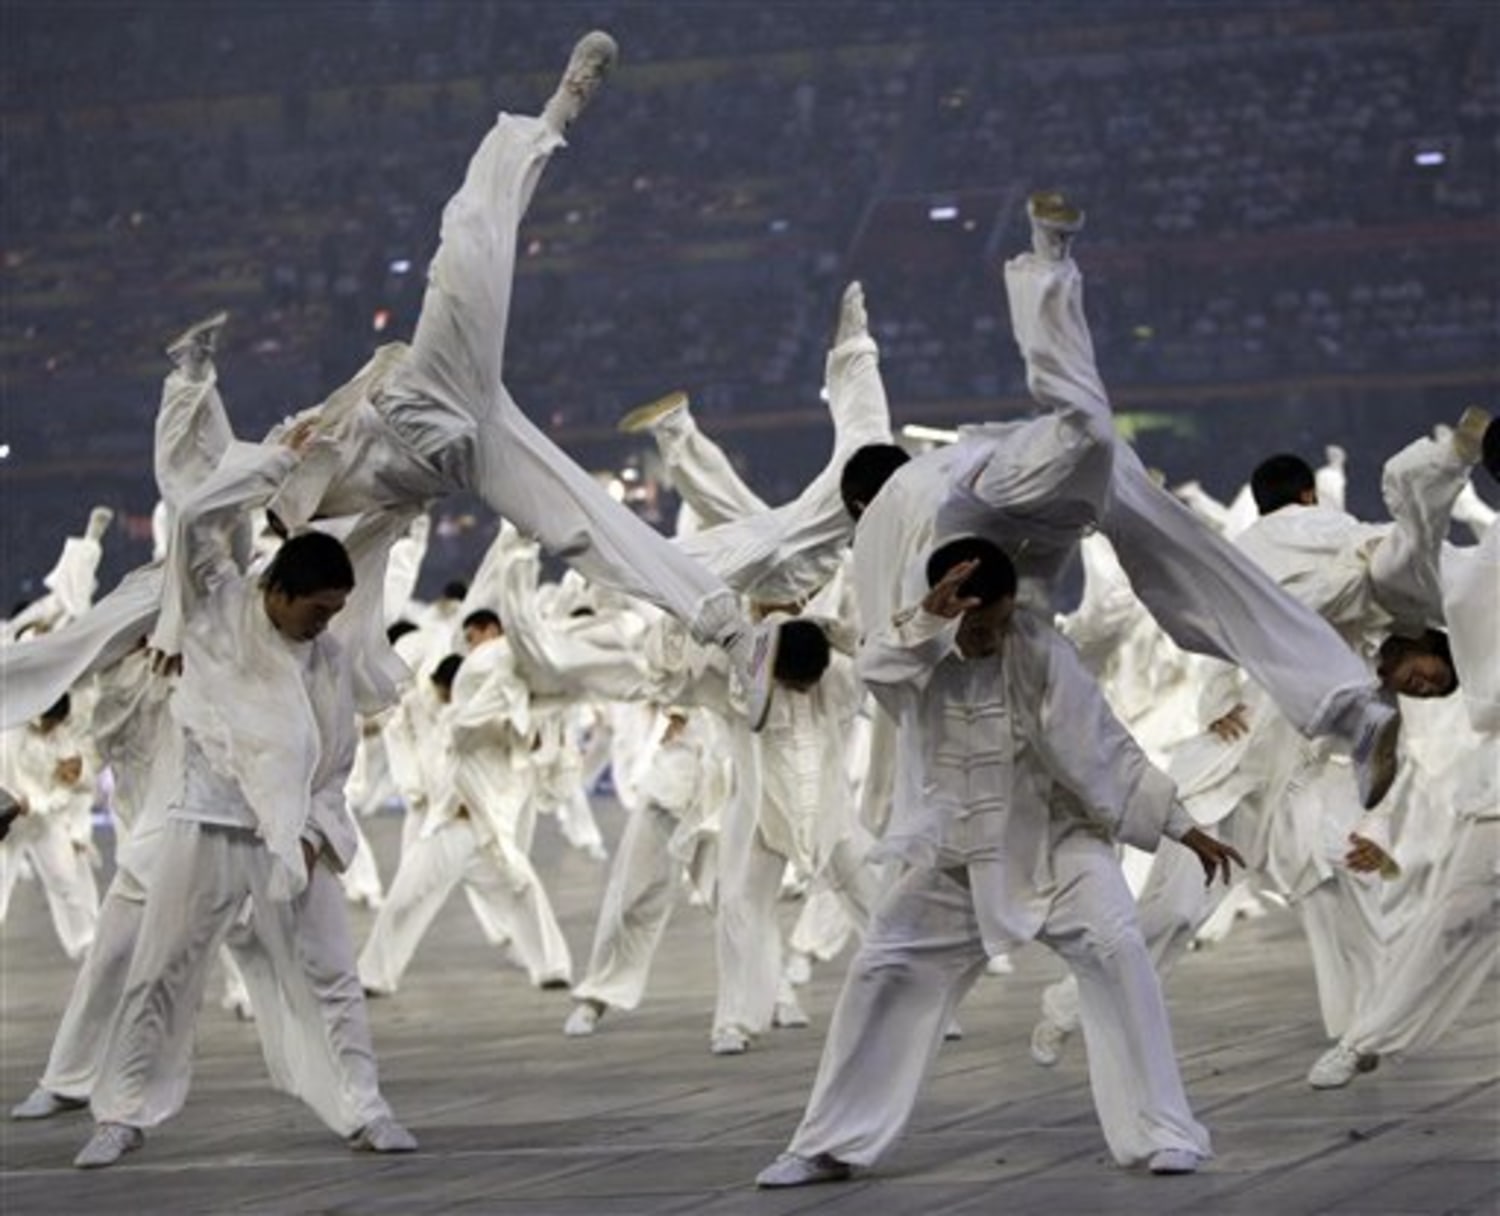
(360, 811, 573, 993)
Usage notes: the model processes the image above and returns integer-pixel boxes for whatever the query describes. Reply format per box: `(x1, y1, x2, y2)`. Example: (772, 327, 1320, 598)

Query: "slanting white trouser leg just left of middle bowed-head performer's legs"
(573, 804, 683, 1009)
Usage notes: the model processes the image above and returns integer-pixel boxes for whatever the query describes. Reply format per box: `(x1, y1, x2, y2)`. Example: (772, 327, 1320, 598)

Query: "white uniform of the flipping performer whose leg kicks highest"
(256, 114, 744, 665)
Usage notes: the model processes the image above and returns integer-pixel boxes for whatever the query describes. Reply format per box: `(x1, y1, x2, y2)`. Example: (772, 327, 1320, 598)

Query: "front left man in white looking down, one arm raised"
(75, 458, 416, 1168)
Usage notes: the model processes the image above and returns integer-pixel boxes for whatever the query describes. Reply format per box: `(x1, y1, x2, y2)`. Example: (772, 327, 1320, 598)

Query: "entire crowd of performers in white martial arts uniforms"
(0, 33, 1500, 1186)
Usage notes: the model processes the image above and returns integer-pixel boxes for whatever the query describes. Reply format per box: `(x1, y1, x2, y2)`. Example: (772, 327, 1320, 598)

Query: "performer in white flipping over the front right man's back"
(843, 195, 1400, 805)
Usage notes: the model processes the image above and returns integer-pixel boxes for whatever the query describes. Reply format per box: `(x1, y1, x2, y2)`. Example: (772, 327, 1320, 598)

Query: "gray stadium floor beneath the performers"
(0, 804, 1500, 1216)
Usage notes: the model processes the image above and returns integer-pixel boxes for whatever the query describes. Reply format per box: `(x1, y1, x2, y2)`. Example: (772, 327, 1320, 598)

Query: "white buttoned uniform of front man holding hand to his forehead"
(791, 609, 1209, 1165)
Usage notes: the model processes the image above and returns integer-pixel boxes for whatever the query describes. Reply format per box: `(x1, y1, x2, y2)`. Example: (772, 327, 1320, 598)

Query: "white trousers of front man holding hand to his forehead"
(791, 835, 1209, 1165)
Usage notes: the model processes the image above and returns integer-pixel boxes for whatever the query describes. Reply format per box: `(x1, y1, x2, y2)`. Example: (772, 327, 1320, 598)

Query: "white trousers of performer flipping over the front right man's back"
(977, 253, 1373, 739)
